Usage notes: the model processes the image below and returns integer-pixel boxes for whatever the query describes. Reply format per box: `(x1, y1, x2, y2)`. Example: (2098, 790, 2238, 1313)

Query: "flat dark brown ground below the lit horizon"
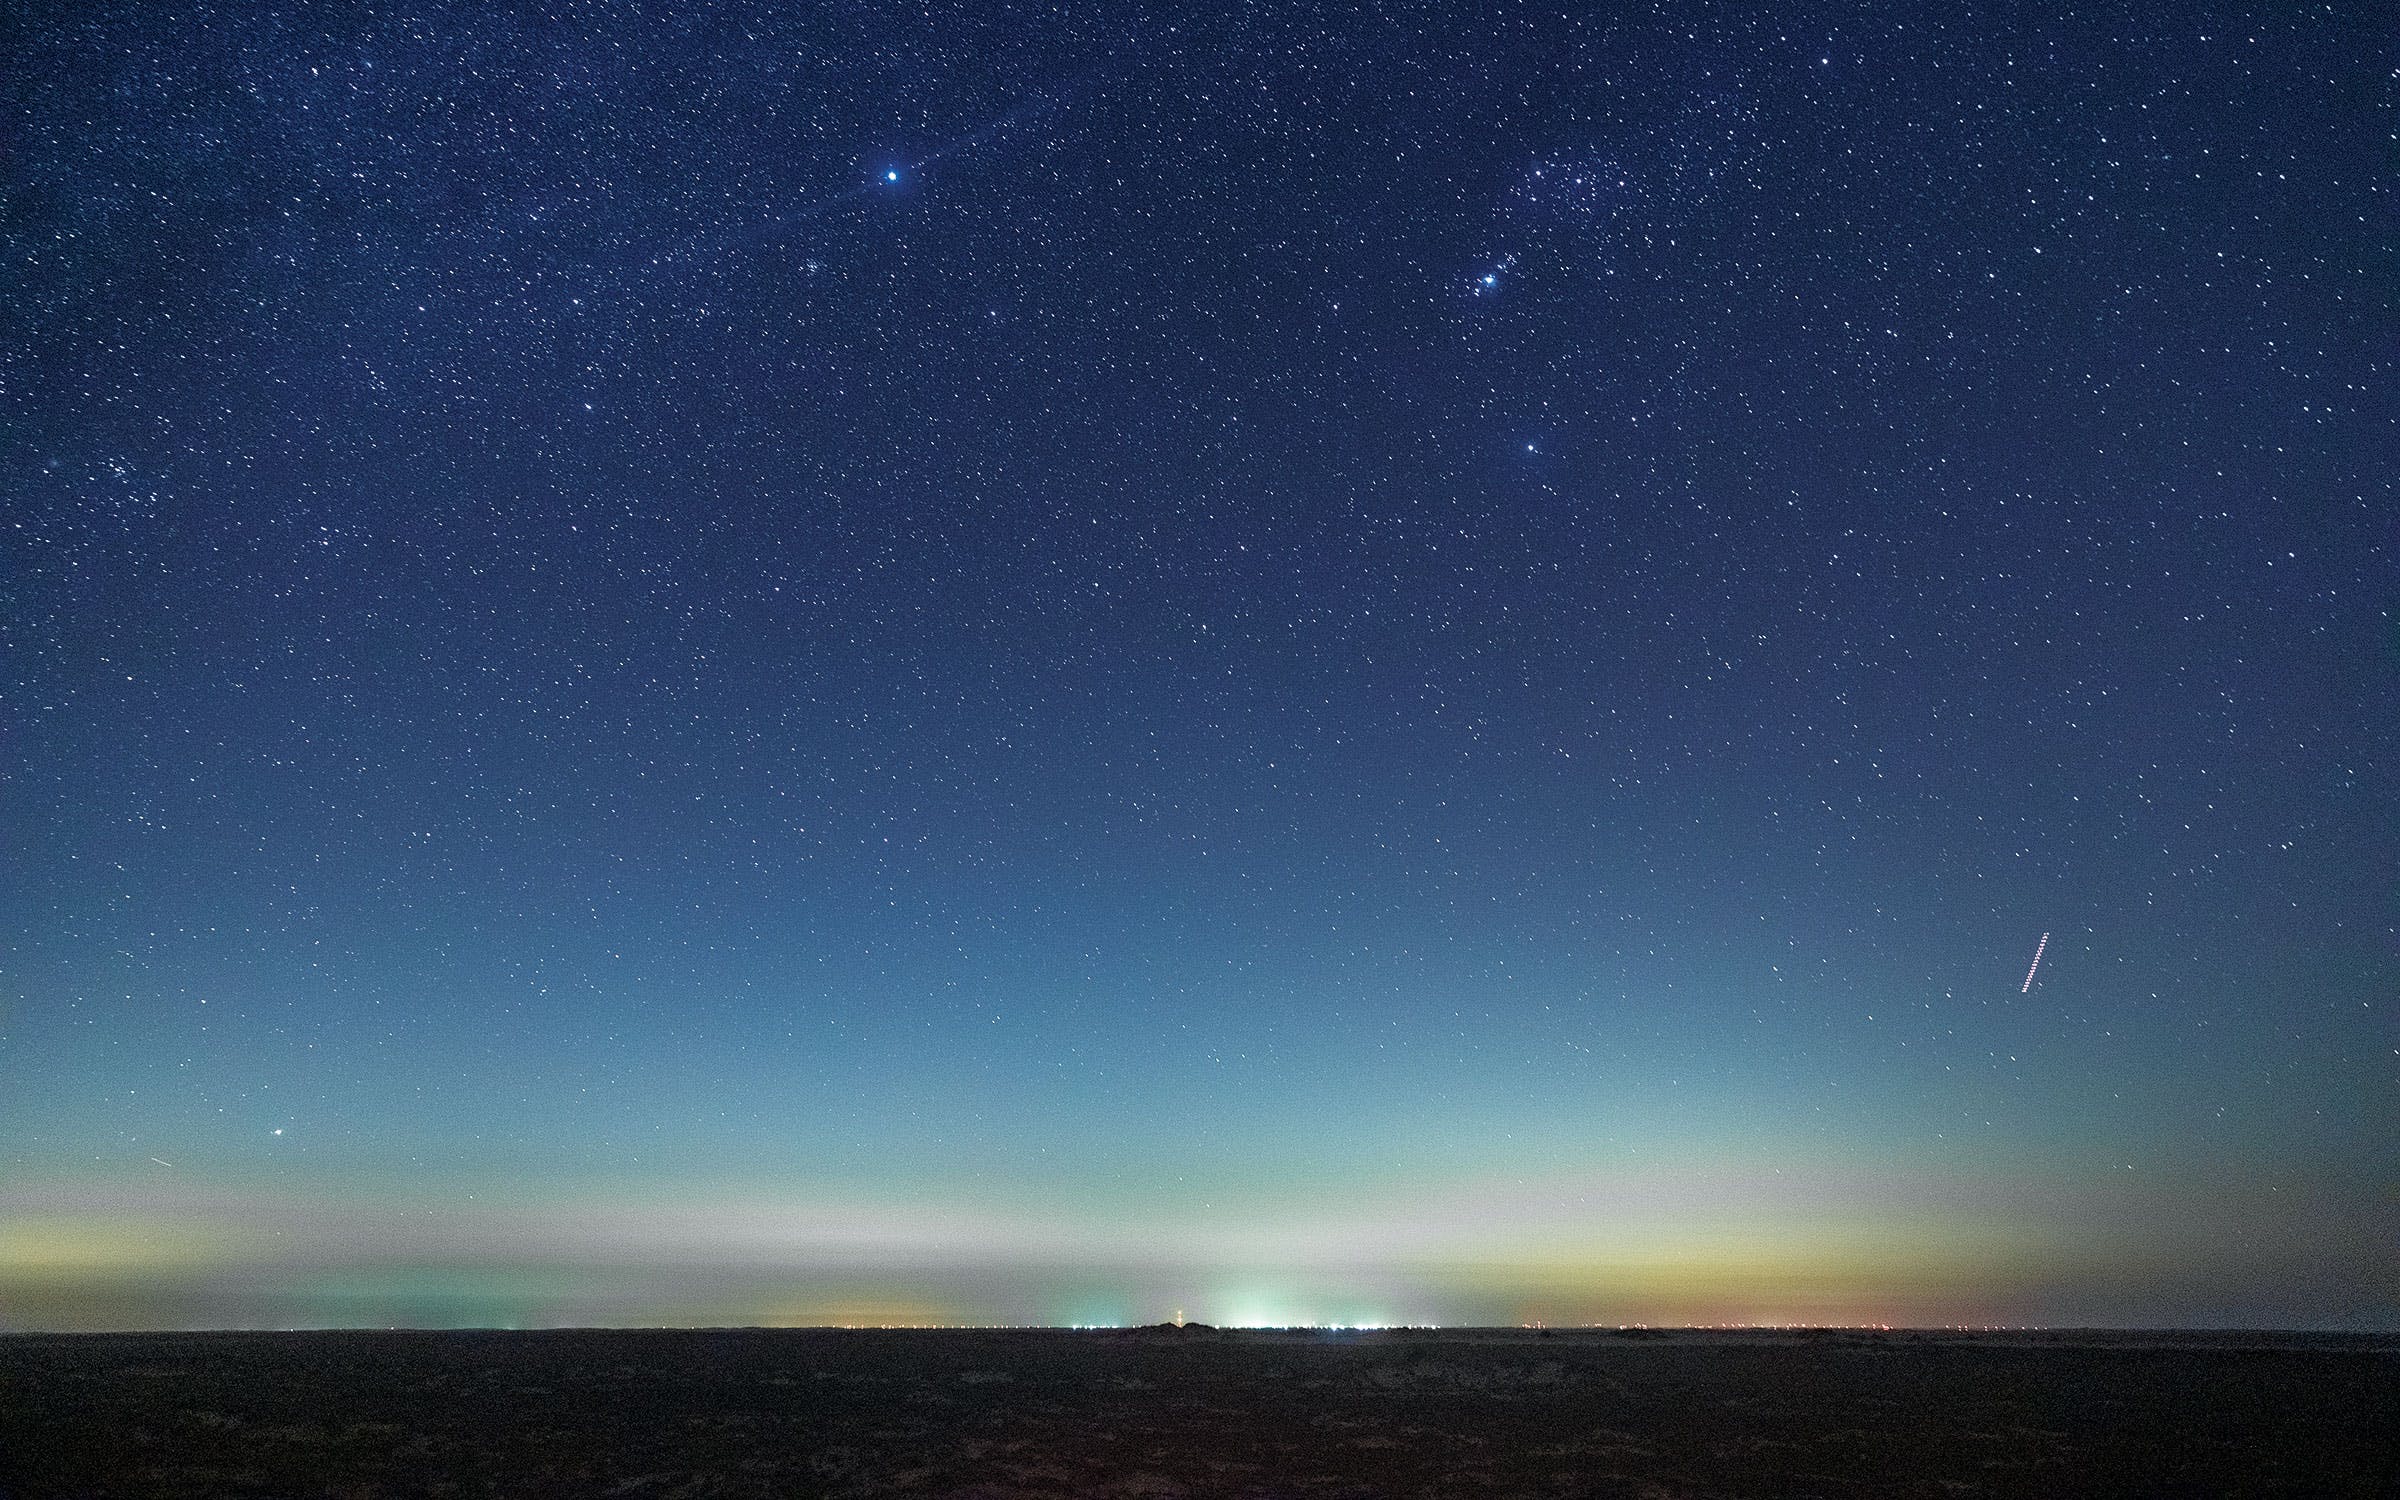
(0, 1330, 2400, 1500)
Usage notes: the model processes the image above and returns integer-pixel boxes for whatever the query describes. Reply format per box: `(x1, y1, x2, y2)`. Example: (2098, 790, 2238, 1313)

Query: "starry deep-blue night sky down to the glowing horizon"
(0, 0, 2400, 1327)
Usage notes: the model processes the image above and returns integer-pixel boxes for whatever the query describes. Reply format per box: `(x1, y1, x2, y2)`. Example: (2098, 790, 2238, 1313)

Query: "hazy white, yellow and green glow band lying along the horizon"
(14, 1152, 2376, 1327)
